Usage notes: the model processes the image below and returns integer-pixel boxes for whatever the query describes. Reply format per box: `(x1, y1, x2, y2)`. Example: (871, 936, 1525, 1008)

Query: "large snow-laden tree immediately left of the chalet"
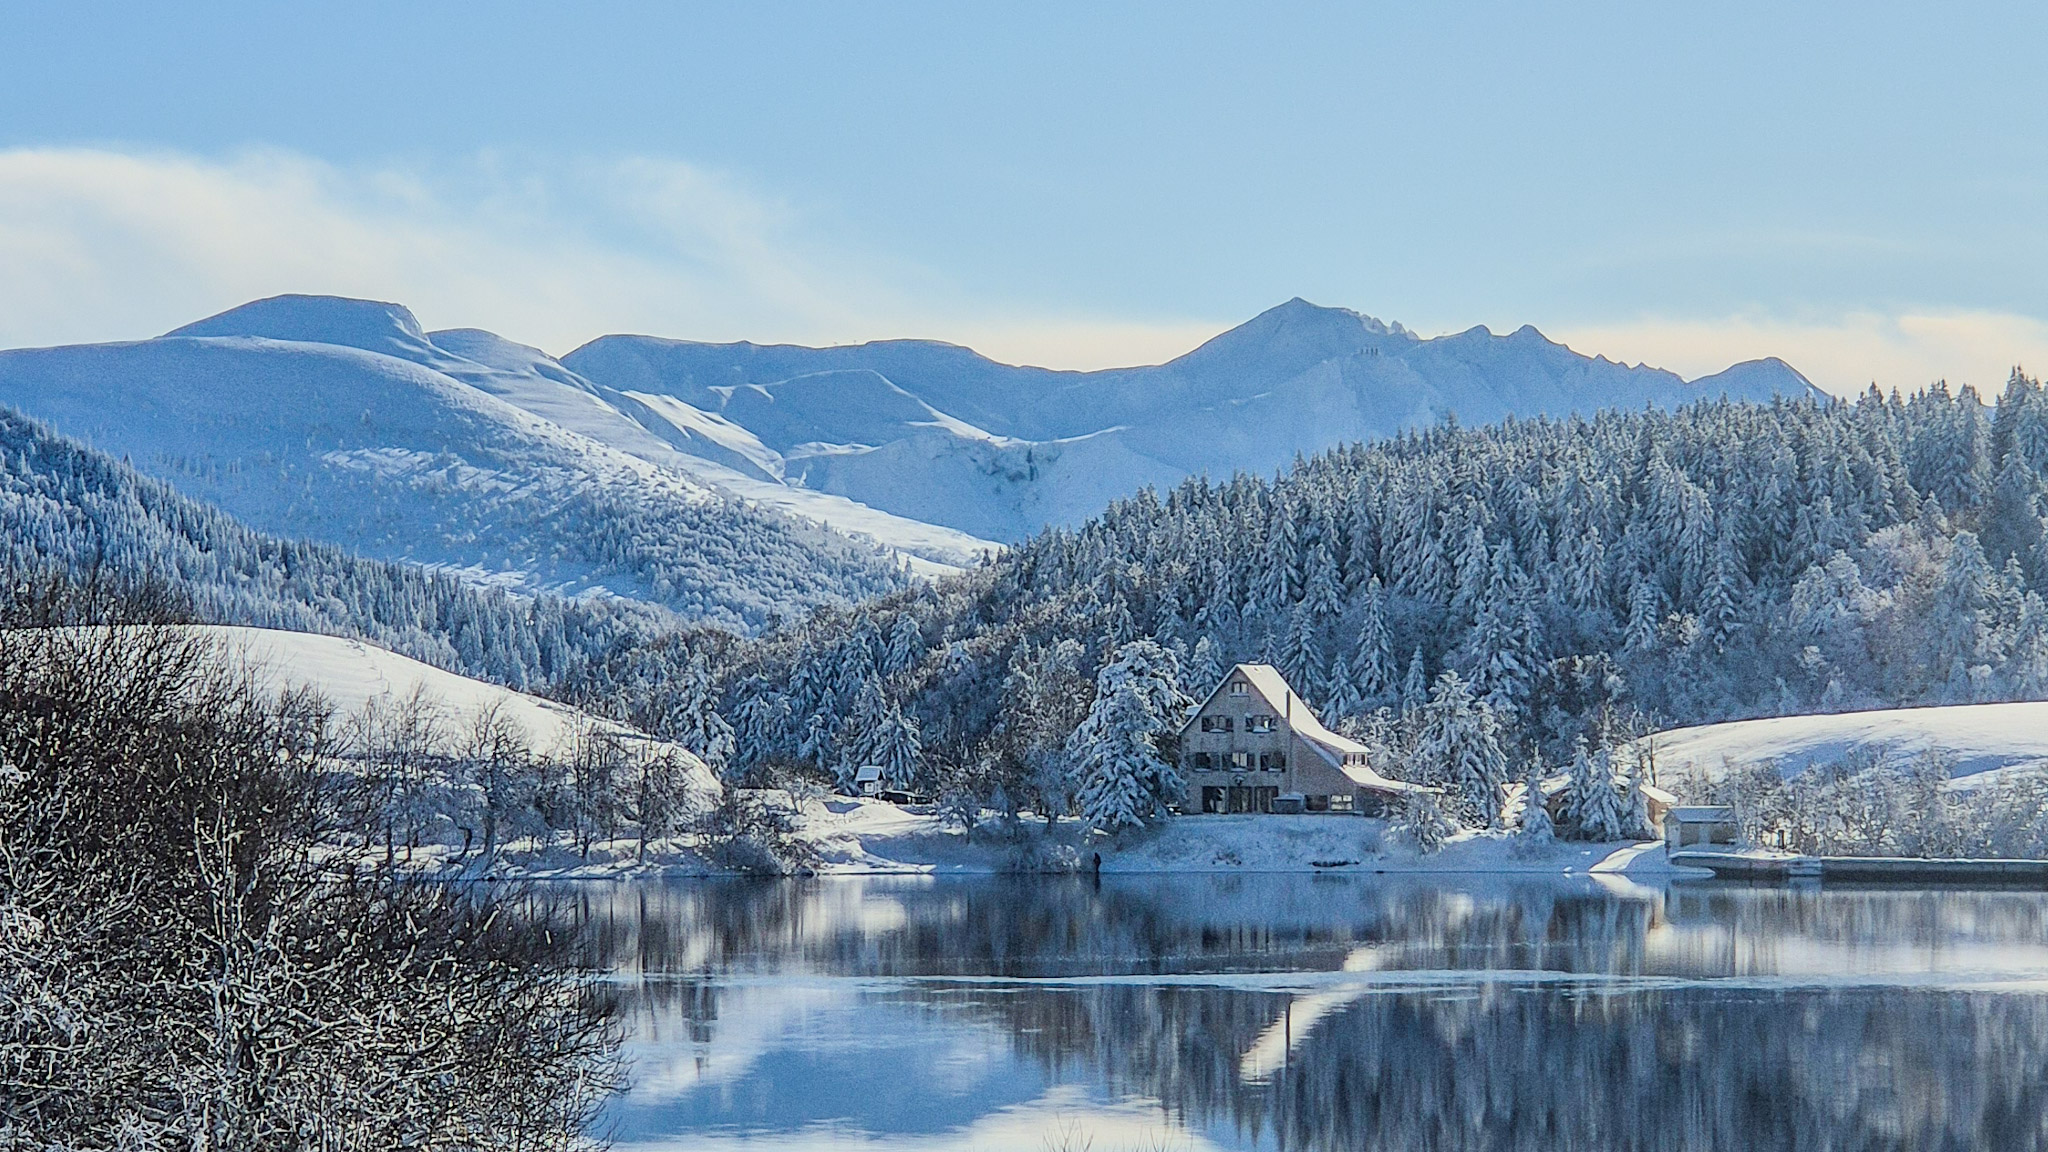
(1067, 640, 1192, 832)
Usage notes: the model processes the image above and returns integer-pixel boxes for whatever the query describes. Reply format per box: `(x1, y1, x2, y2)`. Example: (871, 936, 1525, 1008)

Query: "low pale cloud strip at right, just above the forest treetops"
(1552, 310, 2048, 398)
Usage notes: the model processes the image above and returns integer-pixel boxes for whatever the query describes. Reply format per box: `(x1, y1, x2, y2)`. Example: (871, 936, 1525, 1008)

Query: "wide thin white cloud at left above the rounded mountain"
(0, 148, 1221, 367)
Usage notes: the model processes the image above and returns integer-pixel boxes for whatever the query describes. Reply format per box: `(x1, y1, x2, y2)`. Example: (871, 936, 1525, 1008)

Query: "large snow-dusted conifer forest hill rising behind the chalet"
(727, 373, 2048, 795)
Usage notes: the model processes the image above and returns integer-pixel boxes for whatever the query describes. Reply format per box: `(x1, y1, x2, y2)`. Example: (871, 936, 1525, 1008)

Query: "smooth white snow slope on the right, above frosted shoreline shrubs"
(1655, 703, 2048, 777)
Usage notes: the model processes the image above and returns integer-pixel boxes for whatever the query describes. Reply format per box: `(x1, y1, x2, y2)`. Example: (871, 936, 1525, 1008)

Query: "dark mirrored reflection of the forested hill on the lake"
(548, 877, 2048, 1150)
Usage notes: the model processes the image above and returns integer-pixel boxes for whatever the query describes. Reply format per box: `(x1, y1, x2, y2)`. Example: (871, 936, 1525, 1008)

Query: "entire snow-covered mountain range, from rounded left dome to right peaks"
(0, 295, 1810, 621)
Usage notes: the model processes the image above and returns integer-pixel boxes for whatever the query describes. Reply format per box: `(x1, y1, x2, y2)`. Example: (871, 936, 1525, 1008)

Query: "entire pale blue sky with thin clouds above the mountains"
(0, 0, 2048, 387)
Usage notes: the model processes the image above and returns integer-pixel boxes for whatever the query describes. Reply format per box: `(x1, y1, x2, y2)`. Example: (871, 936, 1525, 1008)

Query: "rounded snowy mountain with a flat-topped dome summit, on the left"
(0, 297, 926, 623)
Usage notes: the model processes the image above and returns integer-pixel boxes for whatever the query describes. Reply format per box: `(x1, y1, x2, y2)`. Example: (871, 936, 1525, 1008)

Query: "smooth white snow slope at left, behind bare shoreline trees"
(200, 625, 719, 793)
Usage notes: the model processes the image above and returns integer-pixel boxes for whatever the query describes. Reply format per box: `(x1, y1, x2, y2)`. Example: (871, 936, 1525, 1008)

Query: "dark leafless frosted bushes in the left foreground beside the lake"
(0, 582, 616, 1152)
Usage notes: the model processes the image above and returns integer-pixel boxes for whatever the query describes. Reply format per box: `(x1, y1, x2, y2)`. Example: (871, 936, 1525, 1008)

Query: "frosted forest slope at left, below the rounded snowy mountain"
(0, 408, 676, 689)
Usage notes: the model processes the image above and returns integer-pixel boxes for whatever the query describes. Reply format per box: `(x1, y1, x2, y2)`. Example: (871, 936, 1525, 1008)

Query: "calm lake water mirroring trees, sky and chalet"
(561, 875, 2048, 1152)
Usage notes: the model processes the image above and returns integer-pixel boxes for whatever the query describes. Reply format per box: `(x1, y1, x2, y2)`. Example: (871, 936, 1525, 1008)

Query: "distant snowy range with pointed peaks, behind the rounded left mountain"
(561, 299, 1812, 539)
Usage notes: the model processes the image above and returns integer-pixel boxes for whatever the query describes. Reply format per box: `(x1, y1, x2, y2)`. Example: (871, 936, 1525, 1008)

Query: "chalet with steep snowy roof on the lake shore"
(1180, 664, 1417, 816)
